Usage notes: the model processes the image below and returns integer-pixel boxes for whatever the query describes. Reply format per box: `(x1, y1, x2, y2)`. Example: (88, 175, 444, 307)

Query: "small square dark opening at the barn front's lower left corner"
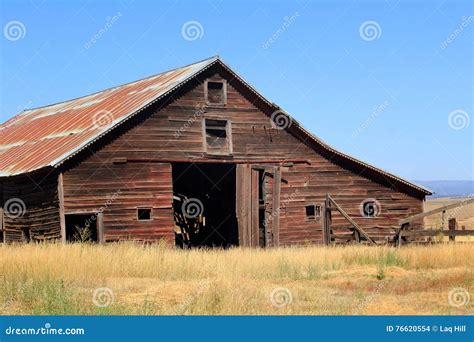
(65, 214, 97, 242)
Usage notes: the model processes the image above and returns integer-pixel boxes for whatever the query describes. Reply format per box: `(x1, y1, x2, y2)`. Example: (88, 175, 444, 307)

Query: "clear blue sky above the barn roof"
(0, 0, 474, 180)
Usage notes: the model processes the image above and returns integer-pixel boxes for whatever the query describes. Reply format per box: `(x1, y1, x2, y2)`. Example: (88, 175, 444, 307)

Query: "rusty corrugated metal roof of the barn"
(0, 56, 431, 195)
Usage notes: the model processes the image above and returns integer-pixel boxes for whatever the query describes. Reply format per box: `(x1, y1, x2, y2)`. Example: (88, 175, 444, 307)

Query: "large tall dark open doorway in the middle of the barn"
(172, 163, 239, 247)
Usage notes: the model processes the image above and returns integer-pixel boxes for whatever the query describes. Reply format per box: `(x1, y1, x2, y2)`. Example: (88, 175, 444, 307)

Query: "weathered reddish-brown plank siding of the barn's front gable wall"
(60, 71, 423, 245)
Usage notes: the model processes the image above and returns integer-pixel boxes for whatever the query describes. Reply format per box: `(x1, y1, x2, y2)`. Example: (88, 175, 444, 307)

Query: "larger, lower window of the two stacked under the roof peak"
(204, 119, 232, 154)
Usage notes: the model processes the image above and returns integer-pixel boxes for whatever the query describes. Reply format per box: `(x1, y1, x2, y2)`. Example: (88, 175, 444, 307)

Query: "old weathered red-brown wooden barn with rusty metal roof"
(0, 57, 430, 247)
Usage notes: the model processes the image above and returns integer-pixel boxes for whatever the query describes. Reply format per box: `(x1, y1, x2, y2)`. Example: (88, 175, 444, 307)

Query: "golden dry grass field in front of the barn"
(0, 243, 474, 315)
